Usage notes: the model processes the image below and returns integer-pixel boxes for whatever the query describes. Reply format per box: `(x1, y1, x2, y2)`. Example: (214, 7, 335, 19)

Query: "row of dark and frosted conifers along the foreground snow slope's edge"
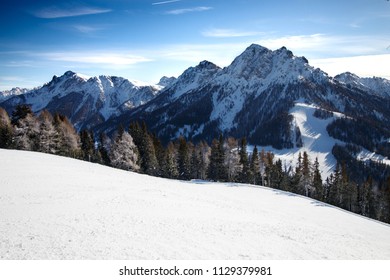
(0, 105, 390, 223)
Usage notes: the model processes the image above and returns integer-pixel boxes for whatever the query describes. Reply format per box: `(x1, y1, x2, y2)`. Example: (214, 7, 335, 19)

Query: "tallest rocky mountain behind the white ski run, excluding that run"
(119, 45, 390, 143)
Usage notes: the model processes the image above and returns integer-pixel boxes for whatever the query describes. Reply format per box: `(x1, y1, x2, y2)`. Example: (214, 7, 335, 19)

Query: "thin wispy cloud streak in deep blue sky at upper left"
(32, 6, 112, 19)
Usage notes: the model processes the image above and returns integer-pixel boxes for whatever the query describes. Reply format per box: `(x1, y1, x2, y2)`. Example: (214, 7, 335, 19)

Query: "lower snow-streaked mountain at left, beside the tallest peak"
(0, 71, 163, 129)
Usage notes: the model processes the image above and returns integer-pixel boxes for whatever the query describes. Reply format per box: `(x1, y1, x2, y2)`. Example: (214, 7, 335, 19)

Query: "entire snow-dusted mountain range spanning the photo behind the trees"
(0, 44, 390, 178)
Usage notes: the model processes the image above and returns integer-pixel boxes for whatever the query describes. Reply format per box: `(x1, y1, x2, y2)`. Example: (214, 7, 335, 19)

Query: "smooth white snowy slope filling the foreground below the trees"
(0, 150, 390, 259)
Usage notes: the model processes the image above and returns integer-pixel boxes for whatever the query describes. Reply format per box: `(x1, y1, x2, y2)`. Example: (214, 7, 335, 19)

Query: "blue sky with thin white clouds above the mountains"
(0, 0, 390, 90)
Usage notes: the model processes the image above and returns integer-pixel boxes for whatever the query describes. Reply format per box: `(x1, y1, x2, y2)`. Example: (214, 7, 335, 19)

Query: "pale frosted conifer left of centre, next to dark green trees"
(109, 129, 140, 171)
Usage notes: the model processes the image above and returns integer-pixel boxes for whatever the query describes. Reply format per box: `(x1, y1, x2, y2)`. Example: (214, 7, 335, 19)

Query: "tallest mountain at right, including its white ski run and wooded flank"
(100, 45, 390, 179)
